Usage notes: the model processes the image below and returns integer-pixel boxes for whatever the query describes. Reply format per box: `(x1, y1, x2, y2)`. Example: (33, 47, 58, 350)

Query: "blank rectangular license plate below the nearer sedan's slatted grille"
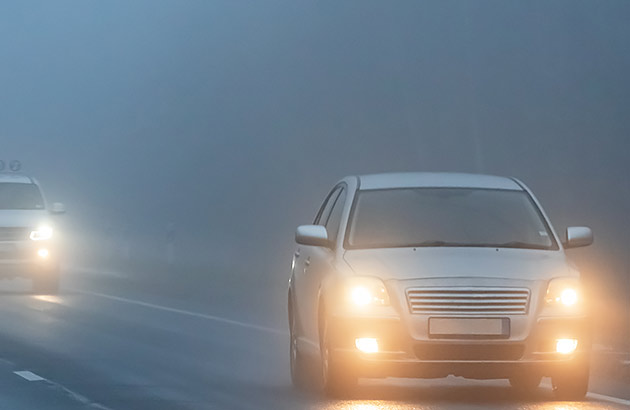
(429, 317, 510, 339)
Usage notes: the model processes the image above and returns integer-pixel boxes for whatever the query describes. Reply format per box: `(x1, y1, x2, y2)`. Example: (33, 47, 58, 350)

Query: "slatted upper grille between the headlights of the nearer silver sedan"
(407, 287, 529, 315)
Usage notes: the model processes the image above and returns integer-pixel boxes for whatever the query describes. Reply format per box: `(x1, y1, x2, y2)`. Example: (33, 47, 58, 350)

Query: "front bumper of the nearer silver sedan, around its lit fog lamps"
(330, 317, 591, 379)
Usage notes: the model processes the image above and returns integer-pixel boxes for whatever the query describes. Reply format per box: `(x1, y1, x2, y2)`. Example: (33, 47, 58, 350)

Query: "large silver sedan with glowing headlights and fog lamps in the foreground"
(288, 173, 593, 399)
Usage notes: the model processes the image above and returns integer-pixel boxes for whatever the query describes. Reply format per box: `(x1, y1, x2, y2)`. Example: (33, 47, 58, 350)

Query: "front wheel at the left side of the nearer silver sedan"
(320, 322, 357, 398)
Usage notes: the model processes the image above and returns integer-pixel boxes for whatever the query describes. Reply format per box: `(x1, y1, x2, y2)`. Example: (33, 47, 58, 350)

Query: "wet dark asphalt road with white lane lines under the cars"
(0, 274, 630, 410)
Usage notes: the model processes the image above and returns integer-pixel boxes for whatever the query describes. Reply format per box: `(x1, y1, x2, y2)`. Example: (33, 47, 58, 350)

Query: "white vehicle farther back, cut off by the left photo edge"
(0, 161, 65, 294)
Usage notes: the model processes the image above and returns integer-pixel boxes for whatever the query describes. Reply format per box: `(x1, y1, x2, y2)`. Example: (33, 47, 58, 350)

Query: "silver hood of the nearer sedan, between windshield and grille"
(344, 248, 572, 280)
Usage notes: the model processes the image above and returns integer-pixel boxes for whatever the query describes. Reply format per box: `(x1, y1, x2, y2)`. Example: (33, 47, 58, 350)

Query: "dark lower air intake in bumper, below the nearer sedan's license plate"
(414, 343, 525, 361)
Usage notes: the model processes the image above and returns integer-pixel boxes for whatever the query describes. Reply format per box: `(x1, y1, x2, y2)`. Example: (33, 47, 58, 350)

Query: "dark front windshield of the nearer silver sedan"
(346, 188, 557, 249)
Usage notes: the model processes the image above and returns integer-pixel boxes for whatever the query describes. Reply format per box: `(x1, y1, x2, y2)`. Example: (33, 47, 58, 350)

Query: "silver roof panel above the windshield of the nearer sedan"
(358, 172, 523, 191)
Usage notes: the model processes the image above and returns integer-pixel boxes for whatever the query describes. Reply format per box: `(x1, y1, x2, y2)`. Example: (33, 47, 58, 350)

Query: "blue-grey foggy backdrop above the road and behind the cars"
(0, 0, 630, 344)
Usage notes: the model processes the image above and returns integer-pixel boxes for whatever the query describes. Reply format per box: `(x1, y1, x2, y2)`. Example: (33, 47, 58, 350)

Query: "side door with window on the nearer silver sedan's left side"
(292, 187, 341, 343)
